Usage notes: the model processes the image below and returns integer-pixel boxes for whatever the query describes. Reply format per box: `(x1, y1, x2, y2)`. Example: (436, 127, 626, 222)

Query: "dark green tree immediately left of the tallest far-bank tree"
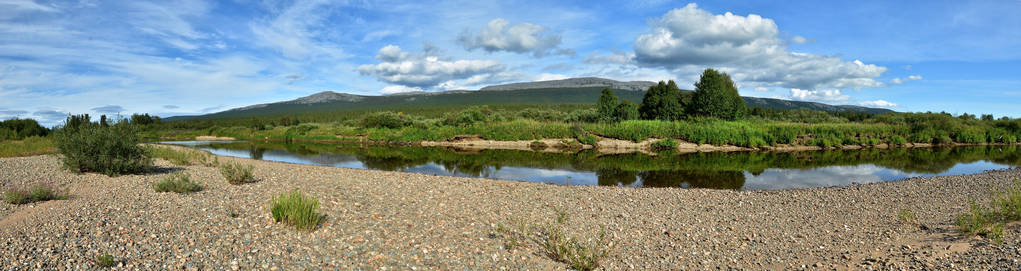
(638, 80, 684, 121)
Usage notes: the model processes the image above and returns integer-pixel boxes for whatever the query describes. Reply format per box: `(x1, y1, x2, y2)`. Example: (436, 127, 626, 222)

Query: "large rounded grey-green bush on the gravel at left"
(54, 117, 152, 176)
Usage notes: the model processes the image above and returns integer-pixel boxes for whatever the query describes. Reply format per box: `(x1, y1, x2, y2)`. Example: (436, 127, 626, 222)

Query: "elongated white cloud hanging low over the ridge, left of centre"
(358, 43, 505, 89)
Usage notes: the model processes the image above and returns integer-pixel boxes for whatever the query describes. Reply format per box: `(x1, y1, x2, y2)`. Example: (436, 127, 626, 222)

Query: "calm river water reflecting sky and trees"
(162, 141, 1021, 190)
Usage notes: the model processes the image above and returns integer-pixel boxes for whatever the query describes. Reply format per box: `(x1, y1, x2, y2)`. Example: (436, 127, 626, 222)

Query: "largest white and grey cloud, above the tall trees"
(634, 4, 886, 90)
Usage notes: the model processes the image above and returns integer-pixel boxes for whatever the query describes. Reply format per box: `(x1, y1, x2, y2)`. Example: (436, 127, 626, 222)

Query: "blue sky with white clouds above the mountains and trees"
(0, 0, 1021, 125)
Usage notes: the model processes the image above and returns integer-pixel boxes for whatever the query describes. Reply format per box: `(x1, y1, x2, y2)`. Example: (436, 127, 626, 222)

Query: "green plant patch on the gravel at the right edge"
(957, 178, 1021, 243)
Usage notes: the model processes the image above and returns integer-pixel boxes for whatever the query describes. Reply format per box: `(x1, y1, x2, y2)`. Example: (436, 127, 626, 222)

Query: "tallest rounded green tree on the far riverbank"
(688, 69, 748, 121)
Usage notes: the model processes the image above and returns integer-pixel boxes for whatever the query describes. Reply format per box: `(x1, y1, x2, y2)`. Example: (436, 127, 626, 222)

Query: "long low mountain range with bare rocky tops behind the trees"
(165, 78, 892, 121)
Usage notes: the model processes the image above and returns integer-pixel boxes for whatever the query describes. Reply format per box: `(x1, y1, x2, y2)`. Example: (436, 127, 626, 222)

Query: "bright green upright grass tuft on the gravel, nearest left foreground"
(270, 189, 323, 230)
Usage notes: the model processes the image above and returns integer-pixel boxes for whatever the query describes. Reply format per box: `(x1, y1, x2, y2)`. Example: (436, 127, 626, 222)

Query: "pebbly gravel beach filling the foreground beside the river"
(0, 155, 1021, 270)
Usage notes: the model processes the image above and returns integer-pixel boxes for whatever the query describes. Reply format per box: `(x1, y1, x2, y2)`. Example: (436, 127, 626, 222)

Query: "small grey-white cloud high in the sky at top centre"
(457, 18, 575, 57)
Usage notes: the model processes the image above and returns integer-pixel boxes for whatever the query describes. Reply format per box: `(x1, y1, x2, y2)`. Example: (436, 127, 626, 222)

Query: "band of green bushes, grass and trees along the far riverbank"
(0, 69, 1021, 148)
